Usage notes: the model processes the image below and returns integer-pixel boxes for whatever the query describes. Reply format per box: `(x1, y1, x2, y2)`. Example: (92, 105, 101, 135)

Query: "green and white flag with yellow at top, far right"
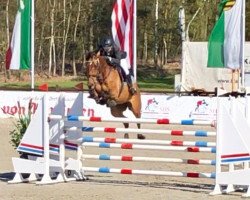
(207, 0, 245, 69)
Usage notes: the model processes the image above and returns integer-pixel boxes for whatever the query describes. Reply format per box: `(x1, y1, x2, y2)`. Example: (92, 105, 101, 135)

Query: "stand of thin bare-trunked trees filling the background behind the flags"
(0, 0, 250, 76)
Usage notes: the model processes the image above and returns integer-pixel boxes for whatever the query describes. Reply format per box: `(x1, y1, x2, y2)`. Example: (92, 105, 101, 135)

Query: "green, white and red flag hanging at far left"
(6, 0, 32, 70)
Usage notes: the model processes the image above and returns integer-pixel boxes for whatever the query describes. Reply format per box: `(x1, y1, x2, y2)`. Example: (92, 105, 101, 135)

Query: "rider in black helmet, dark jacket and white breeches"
(98, 37, 136, 95)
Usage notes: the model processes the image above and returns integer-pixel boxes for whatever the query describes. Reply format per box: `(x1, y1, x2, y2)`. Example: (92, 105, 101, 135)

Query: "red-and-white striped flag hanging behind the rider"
(111, 0, 136, 69)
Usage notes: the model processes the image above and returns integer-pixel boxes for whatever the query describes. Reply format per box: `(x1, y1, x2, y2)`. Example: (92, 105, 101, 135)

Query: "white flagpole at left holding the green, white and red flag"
(30, 0, 35, 90)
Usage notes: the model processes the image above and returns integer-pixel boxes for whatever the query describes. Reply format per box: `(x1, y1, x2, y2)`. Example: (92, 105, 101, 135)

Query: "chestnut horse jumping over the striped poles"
(86, 52, 145, 139)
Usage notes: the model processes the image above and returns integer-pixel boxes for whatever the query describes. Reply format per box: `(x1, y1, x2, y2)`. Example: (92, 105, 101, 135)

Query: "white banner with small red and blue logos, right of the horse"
(142, 94, 217, 120)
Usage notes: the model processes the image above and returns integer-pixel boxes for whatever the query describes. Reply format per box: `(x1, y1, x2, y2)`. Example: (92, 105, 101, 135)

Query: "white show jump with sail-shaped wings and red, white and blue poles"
(10, 93, 250, 196)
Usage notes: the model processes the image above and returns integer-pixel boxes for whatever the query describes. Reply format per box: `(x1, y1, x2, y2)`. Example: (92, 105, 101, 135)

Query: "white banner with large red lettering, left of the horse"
(0, 91, 110, 118)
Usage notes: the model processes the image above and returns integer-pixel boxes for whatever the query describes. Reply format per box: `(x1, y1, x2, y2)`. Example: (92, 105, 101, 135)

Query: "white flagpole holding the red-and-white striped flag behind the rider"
(132, 0, 137, 81)
